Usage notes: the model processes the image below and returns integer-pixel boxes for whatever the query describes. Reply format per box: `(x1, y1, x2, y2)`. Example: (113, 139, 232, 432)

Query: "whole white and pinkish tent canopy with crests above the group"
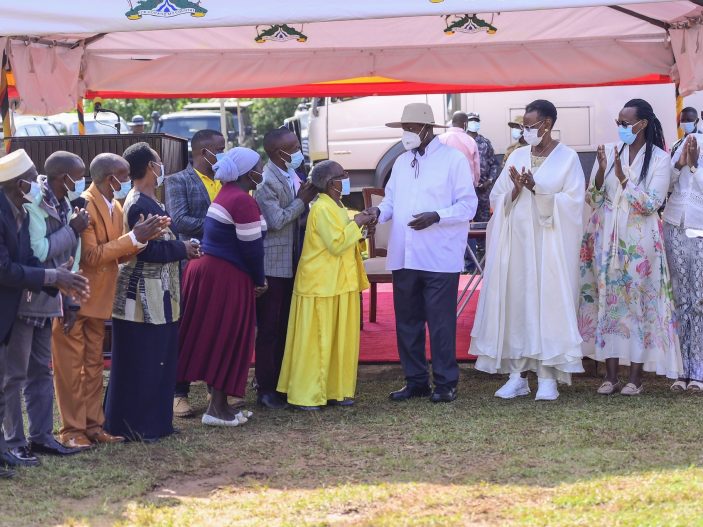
(0, 0, 703, 114)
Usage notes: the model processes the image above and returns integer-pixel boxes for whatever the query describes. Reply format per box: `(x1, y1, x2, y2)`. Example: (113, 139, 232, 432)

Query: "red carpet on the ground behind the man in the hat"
(359, 276, 478, 363)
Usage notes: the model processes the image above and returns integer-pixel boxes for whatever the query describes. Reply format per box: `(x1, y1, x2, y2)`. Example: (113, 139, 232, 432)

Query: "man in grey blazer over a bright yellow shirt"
(164, 130, 225, 417)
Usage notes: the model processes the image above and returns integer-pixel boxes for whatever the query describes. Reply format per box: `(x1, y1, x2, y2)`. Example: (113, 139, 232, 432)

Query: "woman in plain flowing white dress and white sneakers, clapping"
(470, 100, 586, 400)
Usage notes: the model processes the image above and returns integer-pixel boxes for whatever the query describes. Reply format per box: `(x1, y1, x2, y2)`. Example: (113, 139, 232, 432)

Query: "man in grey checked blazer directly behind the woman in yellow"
(254, 128, 317, 408)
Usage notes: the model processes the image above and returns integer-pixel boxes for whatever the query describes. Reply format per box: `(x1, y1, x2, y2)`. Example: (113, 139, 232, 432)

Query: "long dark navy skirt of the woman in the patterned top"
(105, 318, 178, 442)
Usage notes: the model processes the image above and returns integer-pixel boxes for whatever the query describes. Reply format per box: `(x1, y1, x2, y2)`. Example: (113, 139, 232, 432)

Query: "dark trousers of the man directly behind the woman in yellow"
(255, 276, 293, 394)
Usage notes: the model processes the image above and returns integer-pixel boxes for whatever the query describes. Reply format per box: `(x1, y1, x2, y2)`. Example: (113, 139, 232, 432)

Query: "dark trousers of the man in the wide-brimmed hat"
(393, 269, 459, 388)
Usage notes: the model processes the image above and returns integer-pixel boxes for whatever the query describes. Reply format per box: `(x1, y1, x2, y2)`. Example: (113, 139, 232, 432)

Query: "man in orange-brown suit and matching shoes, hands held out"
(52, 154, 169, 448)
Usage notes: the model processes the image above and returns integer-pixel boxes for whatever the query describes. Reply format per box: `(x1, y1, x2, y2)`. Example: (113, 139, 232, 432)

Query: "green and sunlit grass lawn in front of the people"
(0, 366, 703, 527)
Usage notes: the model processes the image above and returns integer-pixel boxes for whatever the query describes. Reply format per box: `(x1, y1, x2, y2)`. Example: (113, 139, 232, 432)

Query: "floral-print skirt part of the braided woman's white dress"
(578, 206, 681, 379)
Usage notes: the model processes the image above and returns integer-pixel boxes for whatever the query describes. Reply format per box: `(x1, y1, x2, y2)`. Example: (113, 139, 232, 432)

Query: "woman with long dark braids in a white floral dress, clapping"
(579, 99, 681, 395)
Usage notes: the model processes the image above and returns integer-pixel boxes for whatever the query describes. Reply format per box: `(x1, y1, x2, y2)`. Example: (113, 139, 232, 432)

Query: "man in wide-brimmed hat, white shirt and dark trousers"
(367, 103, 478, 402)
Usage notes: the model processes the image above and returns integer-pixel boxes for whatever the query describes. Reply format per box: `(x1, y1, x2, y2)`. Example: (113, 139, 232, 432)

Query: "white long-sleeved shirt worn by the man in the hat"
(379, 138, 478, 273)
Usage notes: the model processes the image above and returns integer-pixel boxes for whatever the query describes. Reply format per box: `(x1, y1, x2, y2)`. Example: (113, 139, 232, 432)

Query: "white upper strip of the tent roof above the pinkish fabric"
(0, 0, 680, 36)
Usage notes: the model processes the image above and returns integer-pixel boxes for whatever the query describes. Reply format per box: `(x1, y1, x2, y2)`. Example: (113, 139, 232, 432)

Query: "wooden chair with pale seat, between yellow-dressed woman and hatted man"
(362, 188, 393, 322)
